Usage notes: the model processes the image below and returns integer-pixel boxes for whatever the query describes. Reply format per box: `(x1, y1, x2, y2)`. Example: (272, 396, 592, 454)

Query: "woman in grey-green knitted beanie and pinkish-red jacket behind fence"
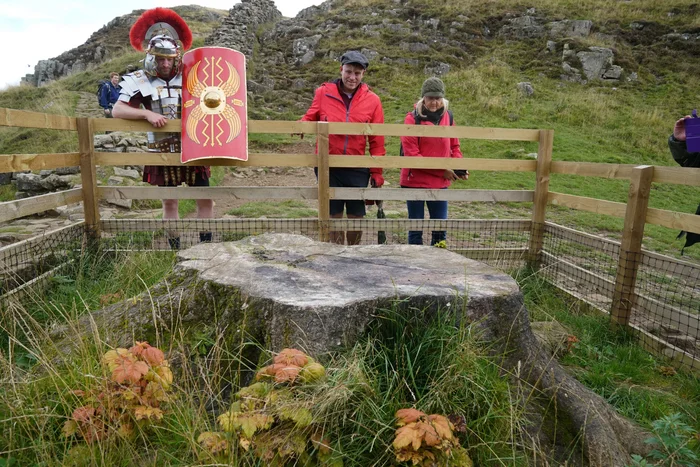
(401, 77, 469, 245)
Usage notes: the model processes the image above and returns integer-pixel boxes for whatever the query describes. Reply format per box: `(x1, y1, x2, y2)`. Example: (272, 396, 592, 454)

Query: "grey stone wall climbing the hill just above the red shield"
(205, 0, 282, 58)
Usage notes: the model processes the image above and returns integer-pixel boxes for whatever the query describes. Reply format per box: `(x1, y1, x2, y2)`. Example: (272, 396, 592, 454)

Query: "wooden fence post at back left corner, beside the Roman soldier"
(76, 118, 100, 240)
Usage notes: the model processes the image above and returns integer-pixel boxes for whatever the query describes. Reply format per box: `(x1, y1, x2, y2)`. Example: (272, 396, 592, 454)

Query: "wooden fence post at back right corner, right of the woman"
(527, 130, 554, 268)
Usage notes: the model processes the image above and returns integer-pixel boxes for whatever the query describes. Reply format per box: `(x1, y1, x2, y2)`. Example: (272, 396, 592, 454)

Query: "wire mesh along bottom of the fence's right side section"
(540, 223, 700, 368)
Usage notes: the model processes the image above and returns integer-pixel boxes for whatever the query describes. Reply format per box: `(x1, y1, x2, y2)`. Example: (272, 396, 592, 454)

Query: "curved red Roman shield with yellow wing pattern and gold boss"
(181, 47, 248, 163)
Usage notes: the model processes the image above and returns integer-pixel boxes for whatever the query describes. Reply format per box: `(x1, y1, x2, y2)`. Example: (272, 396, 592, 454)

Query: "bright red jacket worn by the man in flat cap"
(301, 82, 386, 166)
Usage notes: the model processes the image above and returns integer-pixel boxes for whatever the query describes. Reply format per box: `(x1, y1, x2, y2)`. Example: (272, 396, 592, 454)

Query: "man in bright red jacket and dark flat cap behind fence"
(301, 50, 386, 245)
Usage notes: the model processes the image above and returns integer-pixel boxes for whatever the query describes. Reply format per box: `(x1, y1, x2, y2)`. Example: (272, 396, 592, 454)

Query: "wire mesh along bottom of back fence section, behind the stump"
(101, 218, 530, 269)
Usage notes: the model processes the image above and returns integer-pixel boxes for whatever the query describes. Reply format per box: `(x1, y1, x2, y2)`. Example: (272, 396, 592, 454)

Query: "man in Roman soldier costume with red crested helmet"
(113, 8, 214, 249)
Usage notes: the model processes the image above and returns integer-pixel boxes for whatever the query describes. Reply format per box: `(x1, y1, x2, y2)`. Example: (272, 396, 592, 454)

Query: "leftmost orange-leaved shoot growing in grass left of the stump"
(63, 342, 173, 444)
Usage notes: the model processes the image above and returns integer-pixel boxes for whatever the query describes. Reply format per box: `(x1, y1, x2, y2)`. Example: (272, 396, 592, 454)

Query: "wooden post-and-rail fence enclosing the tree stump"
(0, 108, 700, 367)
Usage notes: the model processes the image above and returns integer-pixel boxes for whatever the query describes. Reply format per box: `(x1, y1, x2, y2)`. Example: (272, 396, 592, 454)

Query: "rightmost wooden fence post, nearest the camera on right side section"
(610, 165, 654, 325)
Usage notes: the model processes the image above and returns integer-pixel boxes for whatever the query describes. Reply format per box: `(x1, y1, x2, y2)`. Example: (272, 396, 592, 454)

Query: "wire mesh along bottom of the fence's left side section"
(0, 222, 84, 297)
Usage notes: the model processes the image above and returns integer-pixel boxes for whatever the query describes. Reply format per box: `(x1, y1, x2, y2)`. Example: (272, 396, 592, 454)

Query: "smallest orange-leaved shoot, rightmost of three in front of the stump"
(392, 409, 473, 467)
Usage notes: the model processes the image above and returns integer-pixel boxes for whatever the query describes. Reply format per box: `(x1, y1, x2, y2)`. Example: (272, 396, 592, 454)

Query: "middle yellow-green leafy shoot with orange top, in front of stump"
(197, 349, 343, 467)
